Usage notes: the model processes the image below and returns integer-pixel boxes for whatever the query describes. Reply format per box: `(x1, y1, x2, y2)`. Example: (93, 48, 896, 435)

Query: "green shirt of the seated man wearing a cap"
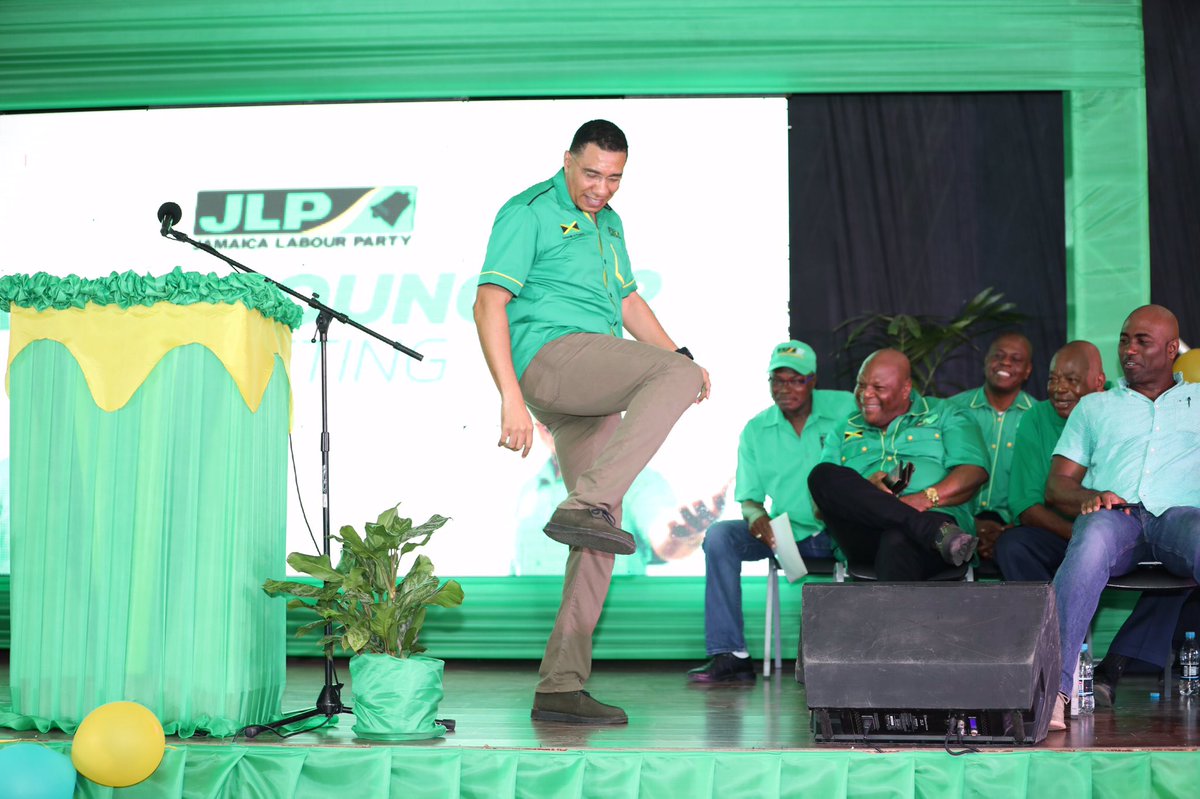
(734, 389, 854, 541)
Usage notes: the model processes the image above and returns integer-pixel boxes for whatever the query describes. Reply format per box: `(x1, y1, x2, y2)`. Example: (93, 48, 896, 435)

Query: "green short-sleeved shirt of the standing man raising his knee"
(479, 170, 637, 379)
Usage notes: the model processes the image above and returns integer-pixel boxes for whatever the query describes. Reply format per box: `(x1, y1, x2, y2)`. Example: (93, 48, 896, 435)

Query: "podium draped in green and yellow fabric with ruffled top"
(0, 269, 301, 737)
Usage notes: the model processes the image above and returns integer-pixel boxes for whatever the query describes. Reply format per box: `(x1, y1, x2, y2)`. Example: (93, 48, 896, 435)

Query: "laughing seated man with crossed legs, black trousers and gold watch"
(809, 349, 989, 581)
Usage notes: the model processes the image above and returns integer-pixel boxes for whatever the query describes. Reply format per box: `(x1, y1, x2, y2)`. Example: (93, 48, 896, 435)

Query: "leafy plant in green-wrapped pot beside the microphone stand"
(263, 507, 463, 740)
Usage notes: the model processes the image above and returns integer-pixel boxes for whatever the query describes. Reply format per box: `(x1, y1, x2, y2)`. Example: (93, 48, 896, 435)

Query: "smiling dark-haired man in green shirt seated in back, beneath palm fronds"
(949, 332, 1033, 558)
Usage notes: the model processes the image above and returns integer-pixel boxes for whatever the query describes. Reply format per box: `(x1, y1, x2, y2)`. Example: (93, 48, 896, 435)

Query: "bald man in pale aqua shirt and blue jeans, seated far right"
(1046, 305, 1200, 729)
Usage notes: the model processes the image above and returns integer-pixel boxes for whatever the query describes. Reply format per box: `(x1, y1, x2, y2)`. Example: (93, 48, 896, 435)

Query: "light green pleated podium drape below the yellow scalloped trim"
(0, 341, 289, 737)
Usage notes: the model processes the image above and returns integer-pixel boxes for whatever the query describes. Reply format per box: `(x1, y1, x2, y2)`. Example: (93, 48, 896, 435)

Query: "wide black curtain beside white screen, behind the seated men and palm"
(788, 92, 1066, 397)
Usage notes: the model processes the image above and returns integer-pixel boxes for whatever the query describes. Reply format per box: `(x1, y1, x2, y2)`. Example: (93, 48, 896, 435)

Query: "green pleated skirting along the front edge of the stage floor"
(0, 743, 1200, 799)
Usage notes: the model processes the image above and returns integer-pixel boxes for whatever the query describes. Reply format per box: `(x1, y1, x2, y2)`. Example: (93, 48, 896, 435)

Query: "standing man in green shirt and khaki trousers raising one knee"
(475, 120, 709, 725)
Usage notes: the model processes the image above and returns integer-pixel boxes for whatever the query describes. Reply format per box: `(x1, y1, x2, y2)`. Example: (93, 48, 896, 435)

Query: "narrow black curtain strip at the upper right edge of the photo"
(1142, 0, 1200, 347)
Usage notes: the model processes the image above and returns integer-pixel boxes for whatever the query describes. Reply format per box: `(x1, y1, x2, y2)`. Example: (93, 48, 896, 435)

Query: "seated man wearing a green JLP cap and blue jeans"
(688, 341, 854, 683)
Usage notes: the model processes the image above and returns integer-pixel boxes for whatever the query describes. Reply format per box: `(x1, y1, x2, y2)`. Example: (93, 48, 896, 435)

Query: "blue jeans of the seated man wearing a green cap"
(704, 519, 833, 655)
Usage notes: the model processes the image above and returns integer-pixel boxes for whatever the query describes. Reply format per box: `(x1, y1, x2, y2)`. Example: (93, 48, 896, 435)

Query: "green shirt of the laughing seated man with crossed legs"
(821, 391, 991, 533)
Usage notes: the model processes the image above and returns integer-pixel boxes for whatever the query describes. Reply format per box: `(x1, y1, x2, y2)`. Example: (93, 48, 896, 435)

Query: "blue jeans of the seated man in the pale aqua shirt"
(1054, 505, 1200, 696)
